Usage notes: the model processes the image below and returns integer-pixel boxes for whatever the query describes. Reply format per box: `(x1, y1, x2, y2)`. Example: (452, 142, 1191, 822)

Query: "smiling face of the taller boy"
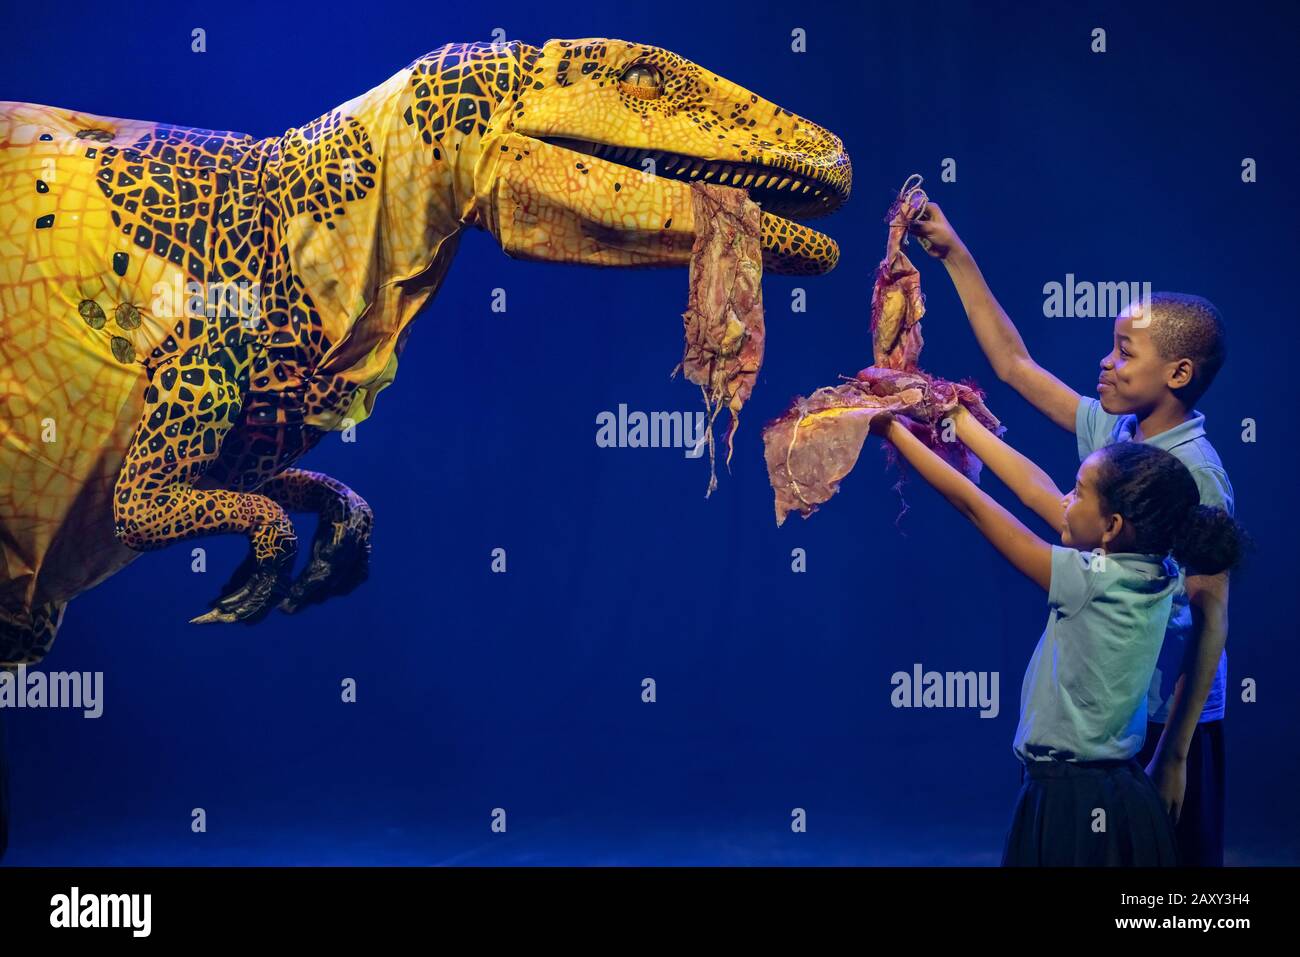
(1097, 302, 1191, 415)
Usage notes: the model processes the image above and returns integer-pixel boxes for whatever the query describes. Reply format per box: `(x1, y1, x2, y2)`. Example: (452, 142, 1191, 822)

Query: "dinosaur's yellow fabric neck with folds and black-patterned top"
(271, 43, 524, 428)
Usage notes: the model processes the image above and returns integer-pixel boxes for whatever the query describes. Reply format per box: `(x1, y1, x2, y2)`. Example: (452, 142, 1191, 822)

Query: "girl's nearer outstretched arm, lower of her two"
(872, 416, 1052, 592)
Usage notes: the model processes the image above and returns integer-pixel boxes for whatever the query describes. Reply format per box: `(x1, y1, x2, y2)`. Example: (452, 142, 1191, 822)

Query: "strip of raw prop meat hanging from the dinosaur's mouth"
(672, 182, 763, 498)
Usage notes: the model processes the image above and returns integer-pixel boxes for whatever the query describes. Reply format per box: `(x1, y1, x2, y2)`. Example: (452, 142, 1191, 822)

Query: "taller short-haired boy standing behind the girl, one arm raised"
(913, 203, 1234, 867)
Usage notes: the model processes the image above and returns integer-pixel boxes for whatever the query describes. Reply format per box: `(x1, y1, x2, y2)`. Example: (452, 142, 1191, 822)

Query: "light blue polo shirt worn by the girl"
(1011, 545, 1183, 762)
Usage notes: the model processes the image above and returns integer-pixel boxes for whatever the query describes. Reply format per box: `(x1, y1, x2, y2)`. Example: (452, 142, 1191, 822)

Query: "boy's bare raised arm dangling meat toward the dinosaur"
(911, 209, 1080, 432)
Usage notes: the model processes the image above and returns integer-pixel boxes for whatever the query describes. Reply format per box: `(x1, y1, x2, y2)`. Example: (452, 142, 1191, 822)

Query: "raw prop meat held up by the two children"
(763, 176, 1004, 525)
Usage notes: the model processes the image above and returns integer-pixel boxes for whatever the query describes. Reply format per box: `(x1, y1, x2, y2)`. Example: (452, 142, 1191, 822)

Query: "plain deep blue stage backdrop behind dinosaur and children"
(0, 0, 1300, 865)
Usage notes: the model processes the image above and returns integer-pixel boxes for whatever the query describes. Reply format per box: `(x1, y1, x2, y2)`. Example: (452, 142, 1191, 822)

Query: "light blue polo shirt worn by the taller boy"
(1074, 395, 1234, 723)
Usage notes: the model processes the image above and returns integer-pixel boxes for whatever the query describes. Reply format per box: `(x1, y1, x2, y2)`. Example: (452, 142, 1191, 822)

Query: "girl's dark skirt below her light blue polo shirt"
(1002, 759, 1178, 867)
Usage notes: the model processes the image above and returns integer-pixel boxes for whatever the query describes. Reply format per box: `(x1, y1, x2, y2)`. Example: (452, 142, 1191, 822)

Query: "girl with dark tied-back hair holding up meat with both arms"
(872, 408, 1244, 866)
